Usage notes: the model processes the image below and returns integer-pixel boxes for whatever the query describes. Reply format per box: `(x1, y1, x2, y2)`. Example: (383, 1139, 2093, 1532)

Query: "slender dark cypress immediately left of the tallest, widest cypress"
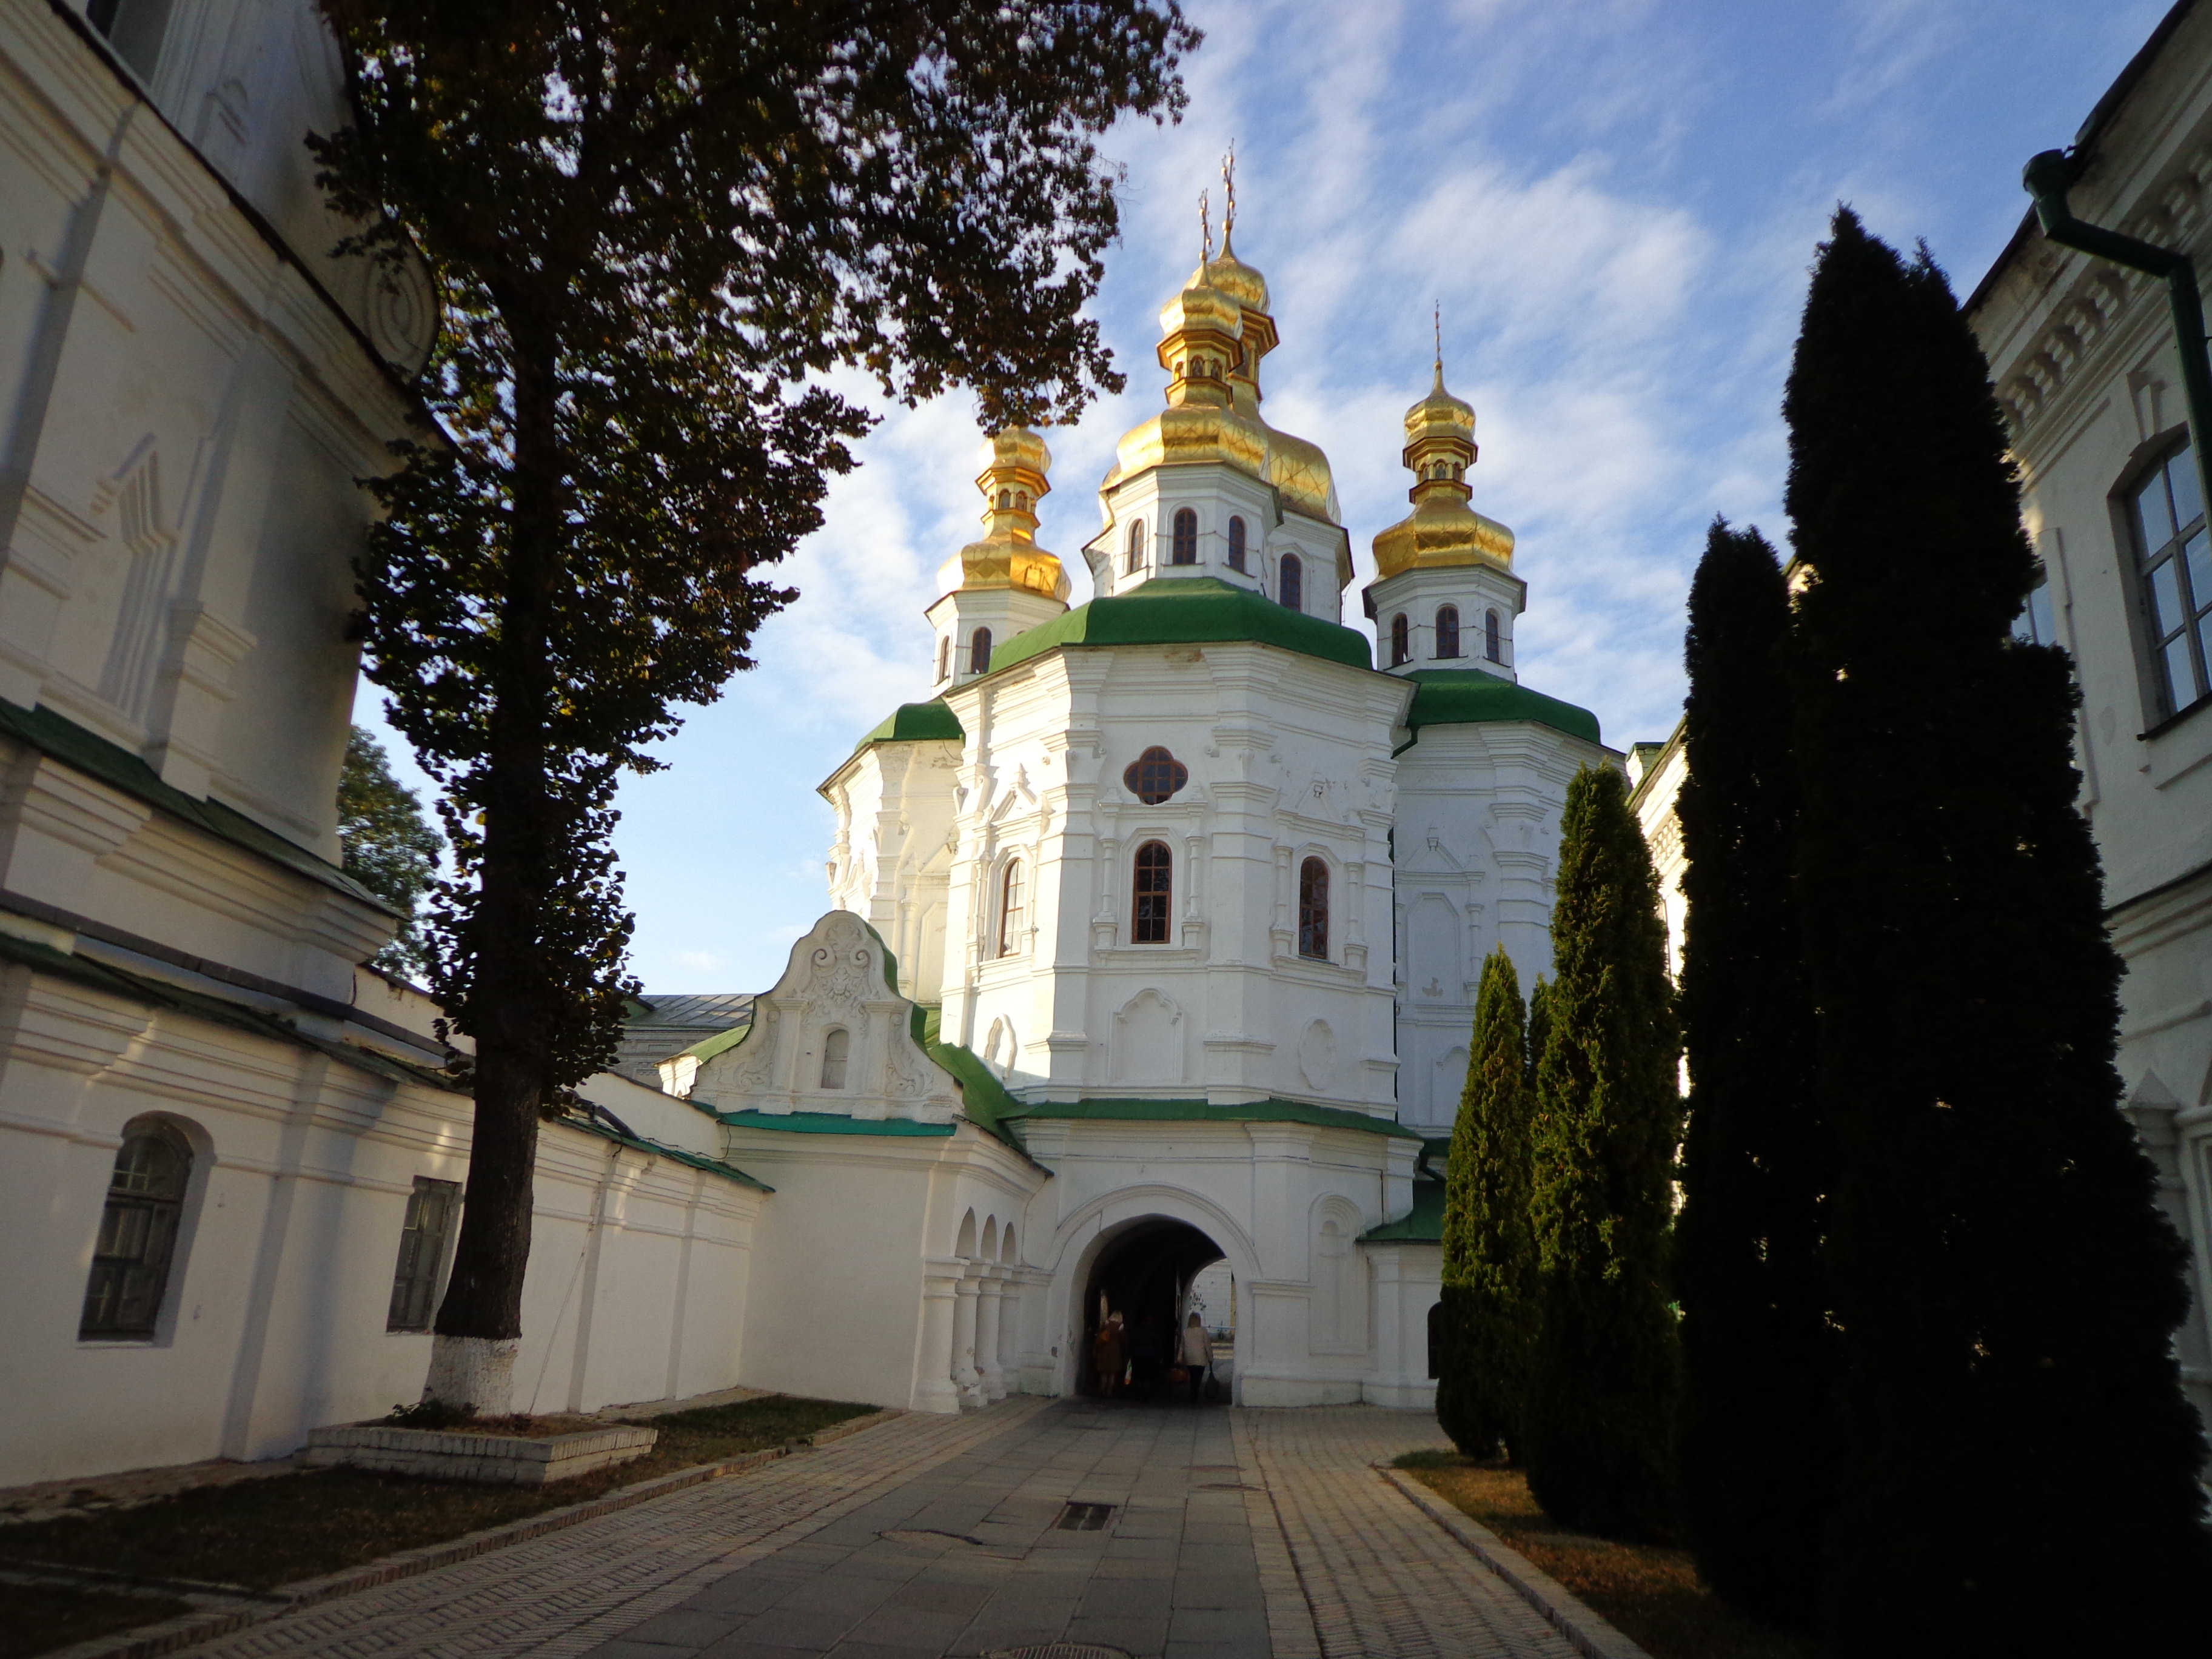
(1675, 522, 1836, 1626)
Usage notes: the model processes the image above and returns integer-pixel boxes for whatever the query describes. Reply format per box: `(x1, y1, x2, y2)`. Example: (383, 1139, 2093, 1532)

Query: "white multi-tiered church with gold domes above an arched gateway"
(659, 236, 1617, 1409)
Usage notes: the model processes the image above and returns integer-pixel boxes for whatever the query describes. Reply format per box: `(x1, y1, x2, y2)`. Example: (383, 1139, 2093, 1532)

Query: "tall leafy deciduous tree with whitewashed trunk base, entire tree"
(317, 0, 1197, 1409)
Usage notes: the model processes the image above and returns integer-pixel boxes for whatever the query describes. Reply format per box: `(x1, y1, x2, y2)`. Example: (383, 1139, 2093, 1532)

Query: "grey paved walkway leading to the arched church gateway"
(172, 1398, 1573, 1659)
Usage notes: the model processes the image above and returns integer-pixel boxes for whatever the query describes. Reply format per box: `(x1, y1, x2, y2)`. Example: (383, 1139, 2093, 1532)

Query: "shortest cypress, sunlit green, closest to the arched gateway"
(1436, 949, 1535, 1458)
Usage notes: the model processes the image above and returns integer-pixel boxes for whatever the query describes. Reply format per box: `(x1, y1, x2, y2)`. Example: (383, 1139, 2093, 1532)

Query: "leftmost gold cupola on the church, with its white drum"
(925, 427, 1068, 692)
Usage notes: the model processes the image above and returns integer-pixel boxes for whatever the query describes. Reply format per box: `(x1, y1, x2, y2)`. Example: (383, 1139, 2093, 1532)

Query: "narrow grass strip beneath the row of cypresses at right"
(1398, 1451, 1827, 1659)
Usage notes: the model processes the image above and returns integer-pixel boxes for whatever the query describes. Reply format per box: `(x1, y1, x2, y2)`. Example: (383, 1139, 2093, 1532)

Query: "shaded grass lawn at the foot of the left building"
(0, 1393, 876, 1659)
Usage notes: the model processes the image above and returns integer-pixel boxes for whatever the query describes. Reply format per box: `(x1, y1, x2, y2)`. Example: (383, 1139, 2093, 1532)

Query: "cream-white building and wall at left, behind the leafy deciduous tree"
(0, 0, 765, 1484)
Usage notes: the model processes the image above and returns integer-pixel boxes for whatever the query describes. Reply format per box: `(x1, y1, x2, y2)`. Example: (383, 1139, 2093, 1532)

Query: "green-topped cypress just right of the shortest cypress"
(1522, 768, 1681, 1537)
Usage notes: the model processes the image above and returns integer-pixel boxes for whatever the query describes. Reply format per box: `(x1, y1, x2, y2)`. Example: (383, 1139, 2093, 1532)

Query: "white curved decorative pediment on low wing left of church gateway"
(690, 909, 960, 1124)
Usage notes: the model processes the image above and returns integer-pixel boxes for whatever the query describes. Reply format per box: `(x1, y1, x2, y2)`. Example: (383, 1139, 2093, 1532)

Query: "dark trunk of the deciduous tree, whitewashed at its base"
(423, 305, 562, 1416)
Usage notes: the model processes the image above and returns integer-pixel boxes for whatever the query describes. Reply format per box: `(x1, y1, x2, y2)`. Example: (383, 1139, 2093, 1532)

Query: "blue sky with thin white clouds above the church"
(358, 0, 2165, 991)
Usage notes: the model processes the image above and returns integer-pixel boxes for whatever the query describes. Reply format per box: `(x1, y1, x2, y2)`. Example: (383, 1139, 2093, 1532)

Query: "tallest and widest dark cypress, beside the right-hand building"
(1785, 210, 2212, 1659)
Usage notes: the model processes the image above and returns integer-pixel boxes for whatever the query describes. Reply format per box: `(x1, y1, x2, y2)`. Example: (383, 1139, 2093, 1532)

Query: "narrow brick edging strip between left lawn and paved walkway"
(40, 1409, 905, 1659)
